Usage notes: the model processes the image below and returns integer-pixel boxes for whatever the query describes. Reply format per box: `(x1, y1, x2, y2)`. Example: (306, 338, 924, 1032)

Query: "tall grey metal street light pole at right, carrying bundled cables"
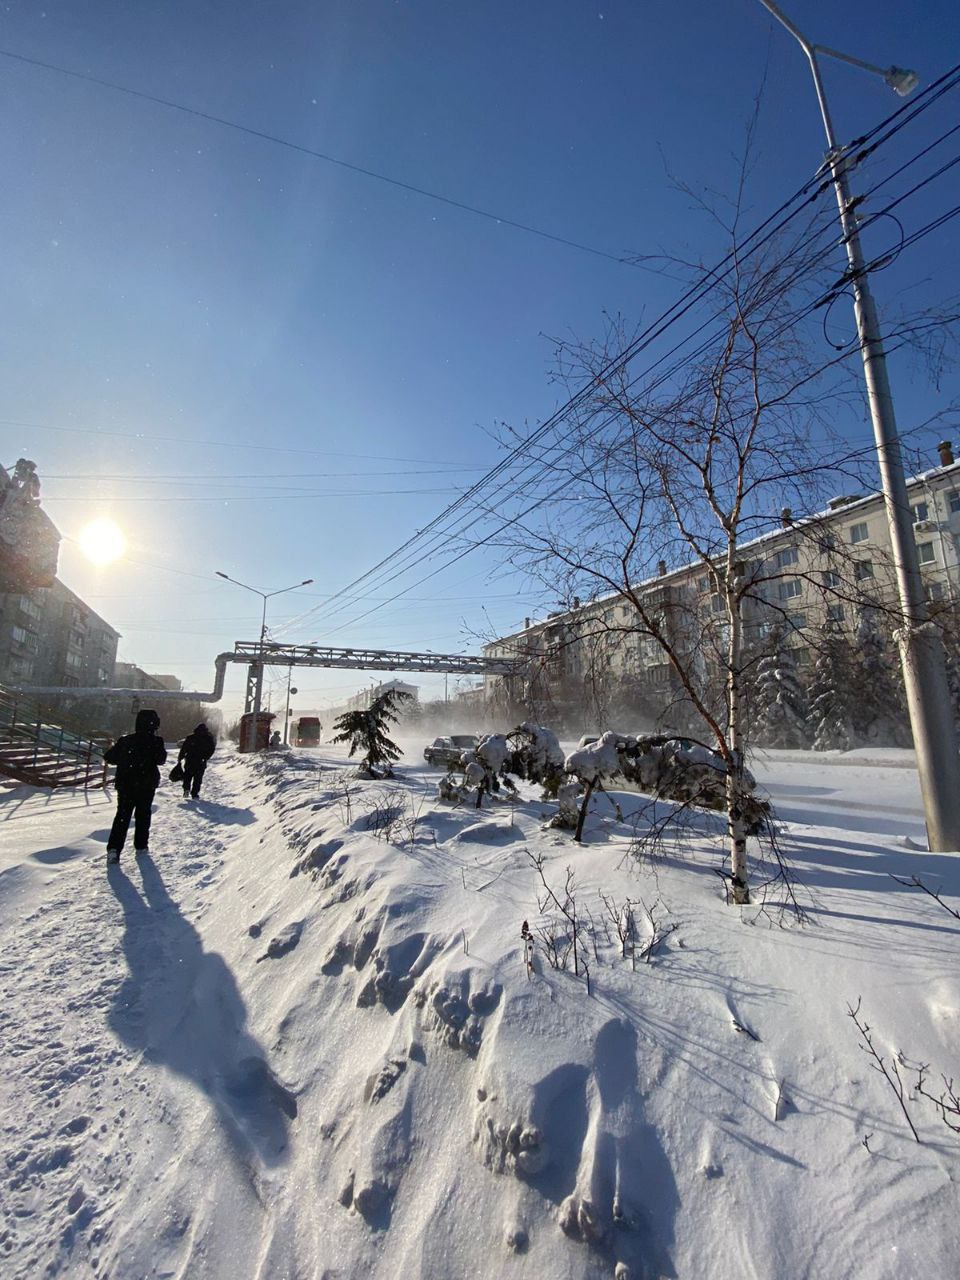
(760, 0, 960, 852)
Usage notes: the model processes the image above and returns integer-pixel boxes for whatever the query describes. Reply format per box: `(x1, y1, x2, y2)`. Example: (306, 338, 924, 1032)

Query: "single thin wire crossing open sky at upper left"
(0, 49, 643, 268)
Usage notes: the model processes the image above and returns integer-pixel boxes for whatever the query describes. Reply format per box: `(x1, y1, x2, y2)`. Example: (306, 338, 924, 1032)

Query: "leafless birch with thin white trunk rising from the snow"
(491, 154, 901, 904)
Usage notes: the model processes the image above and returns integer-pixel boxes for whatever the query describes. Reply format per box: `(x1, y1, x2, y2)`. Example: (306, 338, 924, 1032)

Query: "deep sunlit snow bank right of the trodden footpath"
(217, 753, 960, 1280)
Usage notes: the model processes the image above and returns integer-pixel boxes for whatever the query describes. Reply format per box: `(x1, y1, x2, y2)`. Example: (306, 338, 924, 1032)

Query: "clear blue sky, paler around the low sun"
(0, 0, 960, 709)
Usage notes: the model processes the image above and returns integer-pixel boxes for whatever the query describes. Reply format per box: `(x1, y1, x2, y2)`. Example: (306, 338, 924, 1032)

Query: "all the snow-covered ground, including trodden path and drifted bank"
(0, 740, 960, 1280)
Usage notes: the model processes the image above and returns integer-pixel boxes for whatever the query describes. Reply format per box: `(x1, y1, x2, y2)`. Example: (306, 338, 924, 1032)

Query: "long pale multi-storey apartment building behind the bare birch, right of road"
(484, 443, 960, 707)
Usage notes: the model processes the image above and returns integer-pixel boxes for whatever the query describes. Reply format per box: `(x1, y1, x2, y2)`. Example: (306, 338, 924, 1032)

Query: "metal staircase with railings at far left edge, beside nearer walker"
(0, 689, 113, 787)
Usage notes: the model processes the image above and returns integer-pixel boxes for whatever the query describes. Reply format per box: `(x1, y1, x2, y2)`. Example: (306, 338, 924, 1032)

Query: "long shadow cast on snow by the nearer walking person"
(108, 856, 297, 1166)
